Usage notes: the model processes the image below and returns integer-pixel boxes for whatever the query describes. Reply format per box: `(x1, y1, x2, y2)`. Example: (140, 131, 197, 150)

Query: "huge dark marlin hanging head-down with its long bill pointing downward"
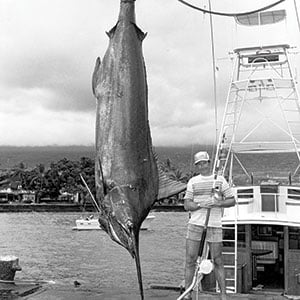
(93, 0, 158, 299)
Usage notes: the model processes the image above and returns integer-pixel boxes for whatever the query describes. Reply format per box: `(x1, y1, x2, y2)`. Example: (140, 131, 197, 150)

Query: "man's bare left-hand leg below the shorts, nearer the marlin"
(185, 238, 200, 289)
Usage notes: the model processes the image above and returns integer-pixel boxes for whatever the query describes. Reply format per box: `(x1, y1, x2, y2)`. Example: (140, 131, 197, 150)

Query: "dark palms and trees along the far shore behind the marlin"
(0, 157, 188, 202)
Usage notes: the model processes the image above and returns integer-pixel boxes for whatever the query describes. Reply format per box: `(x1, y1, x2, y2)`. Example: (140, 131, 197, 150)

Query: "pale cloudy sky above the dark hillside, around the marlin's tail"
(0, 0, 300, 146)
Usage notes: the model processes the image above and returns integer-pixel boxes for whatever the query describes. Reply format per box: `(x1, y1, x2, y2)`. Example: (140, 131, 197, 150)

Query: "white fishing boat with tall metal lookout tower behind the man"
(207, 12, 300, 295)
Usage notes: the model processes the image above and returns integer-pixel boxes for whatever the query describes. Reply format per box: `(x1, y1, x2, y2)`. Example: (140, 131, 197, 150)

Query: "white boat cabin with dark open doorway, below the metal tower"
(223, 181, 300, 295)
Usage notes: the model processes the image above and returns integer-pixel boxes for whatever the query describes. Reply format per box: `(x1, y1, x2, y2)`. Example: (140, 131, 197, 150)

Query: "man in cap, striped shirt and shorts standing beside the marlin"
(184, 151, 235, 300)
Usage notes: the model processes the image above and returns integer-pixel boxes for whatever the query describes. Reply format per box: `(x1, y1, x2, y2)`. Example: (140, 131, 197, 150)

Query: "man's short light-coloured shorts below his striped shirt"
(186, 224, 223, 243)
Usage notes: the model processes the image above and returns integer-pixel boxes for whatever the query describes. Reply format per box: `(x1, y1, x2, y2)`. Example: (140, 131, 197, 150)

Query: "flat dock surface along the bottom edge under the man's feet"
(0, 283, 300, 300)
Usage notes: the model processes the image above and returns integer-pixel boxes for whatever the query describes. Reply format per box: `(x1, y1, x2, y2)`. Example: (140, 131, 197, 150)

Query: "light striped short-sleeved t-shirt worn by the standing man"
(184, 175, 234, 227)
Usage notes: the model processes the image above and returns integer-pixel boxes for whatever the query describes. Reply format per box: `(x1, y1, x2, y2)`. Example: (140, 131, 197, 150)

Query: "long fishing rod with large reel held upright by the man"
(177, 130, 226, 300)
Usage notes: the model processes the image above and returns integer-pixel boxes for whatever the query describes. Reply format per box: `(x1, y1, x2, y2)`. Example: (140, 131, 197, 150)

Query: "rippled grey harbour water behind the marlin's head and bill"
(0, 212, 188, 294)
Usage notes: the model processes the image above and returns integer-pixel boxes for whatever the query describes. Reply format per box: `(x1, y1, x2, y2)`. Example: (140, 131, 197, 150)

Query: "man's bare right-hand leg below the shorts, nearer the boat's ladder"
(209, 242, 226, 300)
